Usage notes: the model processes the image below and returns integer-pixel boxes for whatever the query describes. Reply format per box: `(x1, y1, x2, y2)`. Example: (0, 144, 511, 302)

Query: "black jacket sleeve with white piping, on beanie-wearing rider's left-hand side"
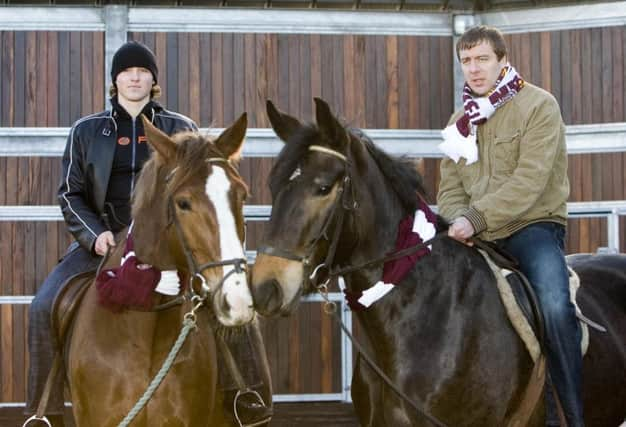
(57, 125, 107, 251)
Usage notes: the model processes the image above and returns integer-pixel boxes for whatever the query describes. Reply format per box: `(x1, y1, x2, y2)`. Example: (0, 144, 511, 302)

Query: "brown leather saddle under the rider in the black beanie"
(50, 270, 96, 351)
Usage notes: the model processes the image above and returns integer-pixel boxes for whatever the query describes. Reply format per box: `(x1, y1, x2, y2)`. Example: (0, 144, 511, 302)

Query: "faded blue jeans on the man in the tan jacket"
(496, 222, 584, 427)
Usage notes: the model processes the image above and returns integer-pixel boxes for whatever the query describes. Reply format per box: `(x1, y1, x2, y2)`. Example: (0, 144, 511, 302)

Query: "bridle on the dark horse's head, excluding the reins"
(257, 145, 358, 288)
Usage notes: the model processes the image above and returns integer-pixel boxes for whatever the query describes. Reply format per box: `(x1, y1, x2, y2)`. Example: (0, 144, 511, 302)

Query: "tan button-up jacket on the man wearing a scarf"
(437, 83, 569, 240)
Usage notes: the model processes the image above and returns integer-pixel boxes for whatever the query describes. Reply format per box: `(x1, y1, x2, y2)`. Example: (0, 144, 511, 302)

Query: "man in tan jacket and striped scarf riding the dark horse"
(437, 26, 583, 427)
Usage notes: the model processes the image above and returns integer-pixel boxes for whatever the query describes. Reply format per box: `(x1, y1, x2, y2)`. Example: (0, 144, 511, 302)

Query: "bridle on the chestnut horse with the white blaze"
(165, 157, 248, 300)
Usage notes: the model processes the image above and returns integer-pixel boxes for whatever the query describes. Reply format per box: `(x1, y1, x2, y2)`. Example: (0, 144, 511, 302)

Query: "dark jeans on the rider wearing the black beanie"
(24, 242, 102, 415)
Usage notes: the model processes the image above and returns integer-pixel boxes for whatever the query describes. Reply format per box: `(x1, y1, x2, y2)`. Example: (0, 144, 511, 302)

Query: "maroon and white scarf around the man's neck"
(439, 64, 524, 165)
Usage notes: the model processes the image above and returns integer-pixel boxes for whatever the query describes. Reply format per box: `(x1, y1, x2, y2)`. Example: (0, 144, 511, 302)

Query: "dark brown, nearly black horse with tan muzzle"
(252, 99, 626, 427)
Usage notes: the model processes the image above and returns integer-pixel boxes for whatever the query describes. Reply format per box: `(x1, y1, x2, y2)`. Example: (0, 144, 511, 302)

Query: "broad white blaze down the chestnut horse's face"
(206, 165, 254, 326)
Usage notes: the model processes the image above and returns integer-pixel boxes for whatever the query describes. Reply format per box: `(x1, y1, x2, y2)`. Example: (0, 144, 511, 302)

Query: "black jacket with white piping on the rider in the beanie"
(57, 102, 197, 251)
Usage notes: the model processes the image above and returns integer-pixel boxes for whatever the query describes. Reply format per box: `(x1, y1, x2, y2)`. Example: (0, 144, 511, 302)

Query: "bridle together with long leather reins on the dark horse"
(257, 145, 446, 427)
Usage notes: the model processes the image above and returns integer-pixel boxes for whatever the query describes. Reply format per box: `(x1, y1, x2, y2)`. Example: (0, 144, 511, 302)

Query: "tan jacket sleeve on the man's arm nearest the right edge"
(464, 97, 565, 233)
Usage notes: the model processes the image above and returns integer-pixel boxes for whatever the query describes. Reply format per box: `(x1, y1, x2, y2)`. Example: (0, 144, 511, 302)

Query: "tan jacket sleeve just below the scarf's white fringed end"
(437, 157, 469, 221)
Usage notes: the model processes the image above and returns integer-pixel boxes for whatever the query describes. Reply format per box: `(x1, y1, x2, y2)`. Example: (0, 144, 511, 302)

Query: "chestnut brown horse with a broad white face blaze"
(66, 114, 269, 427)
